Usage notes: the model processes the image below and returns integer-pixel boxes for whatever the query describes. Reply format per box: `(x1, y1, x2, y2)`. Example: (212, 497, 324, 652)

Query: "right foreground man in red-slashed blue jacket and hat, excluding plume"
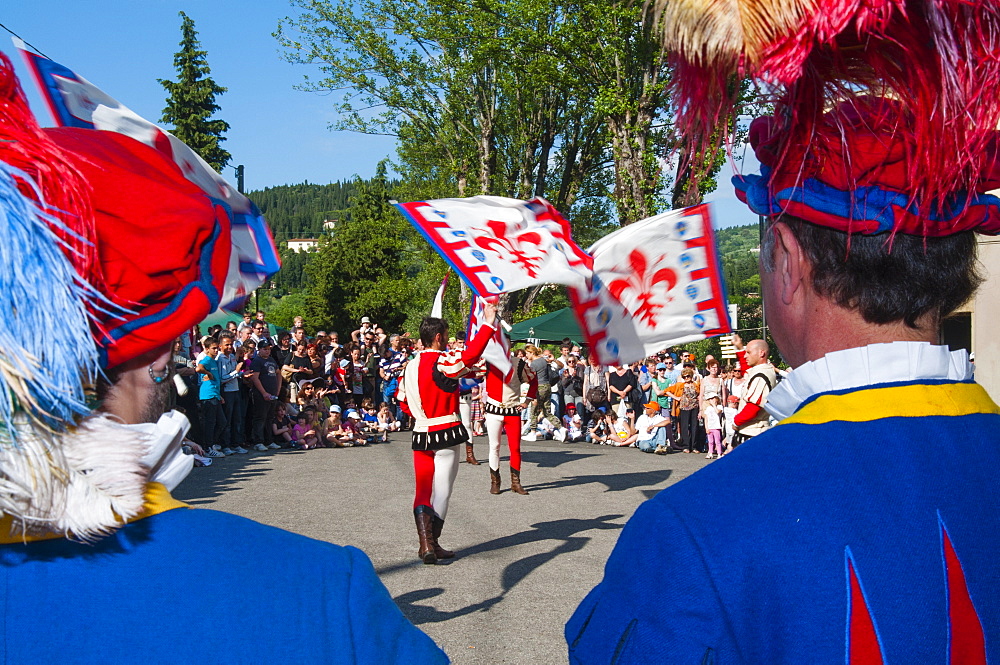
(566, 3, 1000, 665)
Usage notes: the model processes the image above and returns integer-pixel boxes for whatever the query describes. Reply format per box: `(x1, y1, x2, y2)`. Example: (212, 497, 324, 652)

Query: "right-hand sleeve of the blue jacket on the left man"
(342, 547, 449, 665)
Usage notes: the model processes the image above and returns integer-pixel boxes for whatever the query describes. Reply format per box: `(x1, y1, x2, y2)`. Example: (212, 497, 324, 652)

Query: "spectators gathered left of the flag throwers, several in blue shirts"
(173, 312, 413, 463)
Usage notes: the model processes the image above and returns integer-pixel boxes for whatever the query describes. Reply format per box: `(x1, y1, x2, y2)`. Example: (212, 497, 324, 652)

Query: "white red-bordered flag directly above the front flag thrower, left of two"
(397, 196, 590, 296)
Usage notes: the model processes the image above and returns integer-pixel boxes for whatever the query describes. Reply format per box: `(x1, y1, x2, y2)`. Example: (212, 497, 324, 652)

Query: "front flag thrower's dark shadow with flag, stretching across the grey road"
(386, 515, 624, 625)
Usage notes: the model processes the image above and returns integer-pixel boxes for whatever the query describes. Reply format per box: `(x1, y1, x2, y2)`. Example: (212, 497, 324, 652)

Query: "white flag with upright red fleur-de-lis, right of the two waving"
(569, 205, 730, 365)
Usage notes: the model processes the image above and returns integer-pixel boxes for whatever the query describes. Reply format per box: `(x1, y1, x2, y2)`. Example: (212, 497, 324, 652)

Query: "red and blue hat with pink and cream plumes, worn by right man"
(654, 0, 1000, 236)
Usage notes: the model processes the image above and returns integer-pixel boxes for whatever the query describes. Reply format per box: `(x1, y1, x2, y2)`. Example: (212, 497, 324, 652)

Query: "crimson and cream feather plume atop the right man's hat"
(653, 0, 1000, 223)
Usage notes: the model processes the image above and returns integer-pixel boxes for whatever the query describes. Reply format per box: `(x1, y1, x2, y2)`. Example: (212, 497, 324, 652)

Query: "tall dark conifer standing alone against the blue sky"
(157, 12, 231, 171)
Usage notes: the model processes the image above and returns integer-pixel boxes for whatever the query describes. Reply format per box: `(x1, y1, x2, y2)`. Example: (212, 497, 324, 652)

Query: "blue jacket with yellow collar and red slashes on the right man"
(566, 381, 1000, 665)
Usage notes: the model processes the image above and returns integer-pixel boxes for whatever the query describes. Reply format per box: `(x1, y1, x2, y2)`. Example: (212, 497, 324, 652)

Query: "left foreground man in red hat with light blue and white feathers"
(0, 55, 448, 663)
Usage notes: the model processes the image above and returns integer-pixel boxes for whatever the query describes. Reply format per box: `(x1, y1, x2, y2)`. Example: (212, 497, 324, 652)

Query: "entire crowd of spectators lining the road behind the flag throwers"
(174, 312, 766, 459)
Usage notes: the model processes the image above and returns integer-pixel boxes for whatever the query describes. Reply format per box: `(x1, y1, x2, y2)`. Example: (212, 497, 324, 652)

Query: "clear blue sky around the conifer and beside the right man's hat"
(0, 0, 757, 227)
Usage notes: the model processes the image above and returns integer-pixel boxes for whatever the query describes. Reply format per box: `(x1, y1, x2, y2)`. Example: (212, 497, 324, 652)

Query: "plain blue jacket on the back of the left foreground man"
(0, 490, 448, 664)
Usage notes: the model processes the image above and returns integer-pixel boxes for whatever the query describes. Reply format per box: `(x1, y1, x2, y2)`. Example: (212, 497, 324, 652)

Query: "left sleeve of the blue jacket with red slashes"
(565, 500, 735, 665)
